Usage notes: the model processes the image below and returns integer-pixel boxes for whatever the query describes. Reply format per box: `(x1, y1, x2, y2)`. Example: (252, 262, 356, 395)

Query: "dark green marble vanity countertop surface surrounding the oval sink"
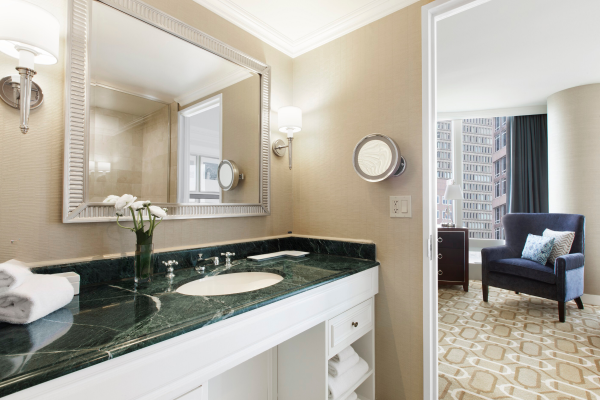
(0, 254, 379, 397)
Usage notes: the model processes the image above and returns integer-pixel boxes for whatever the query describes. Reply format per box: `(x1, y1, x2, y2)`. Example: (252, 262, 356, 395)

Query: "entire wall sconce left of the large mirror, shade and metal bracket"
(0, 0, 60, 133)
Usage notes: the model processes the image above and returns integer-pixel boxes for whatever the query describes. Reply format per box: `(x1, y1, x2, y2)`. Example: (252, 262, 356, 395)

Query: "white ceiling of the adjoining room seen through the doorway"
(437, 0, 600, 112)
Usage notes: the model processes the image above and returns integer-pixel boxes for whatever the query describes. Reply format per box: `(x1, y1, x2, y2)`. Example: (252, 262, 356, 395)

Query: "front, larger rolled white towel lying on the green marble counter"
(0, 274, 73, 324)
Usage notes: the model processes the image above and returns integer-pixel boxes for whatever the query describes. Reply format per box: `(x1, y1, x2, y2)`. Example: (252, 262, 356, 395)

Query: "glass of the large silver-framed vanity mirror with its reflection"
(87, 1, 261, 203)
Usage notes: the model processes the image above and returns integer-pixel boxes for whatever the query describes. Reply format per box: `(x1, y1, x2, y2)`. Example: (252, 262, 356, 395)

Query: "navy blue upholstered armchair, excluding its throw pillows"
(481, 214, 585, 322)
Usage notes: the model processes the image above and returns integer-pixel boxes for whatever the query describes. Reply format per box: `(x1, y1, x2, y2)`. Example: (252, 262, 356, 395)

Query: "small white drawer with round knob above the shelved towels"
(327, 298, 373, 357)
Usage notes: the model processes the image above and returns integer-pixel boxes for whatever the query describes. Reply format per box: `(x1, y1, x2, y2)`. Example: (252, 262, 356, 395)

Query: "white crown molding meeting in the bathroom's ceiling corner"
(194, 0, 418, 58)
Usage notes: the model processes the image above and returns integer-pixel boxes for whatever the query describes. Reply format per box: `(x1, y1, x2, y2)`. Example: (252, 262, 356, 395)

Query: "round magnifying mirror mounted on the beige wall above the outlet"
(352, 133, 401, 182)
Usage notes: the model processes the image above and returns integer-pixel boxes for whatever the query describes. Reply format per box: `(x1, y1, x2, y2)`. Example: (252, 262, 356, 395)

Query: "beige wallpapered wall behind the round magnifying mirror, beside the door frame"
(293, 1, 428, 400)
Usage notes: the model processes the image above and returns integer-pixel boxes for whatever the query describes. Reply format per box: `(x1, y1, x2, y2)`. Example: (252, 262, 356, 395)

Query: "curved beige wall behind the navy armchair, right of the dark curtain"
(548, 83, 600, 296)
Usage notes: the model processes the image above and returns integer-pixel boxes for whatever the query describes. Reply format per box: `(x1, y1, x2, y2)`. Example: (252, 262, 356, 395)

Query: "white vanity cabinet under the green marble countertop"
(5, 267, 379, 400)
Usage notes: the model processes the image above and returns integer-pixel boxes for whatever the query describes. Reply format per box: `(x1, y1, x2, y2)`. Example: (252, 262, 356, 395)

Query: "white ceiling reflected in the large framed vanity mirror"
(90, 1, 253, 105)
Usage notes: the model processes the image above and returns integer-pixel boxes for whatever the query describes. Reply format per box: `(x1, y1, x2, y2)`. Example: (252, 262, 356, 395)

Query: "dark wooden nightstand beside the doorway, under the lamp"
(438, 227, 469, 292)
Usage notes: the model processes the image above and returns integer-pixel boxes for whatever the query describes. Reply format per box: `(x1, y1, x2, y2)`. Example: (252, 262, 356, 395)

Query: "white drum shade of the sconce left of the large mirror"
(0, 0, 60, 65)
